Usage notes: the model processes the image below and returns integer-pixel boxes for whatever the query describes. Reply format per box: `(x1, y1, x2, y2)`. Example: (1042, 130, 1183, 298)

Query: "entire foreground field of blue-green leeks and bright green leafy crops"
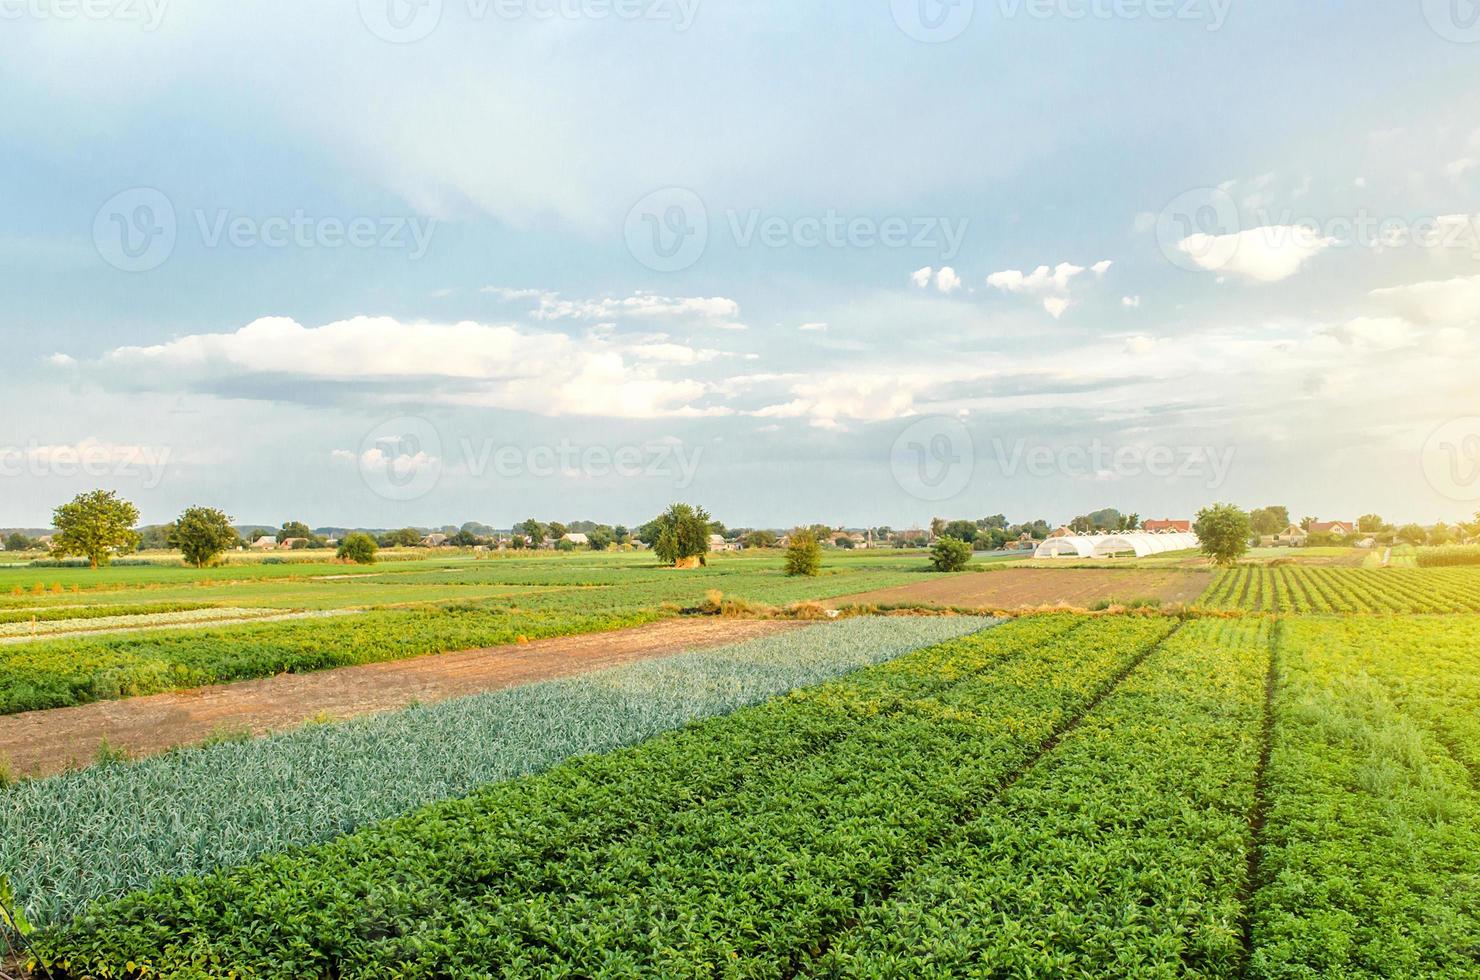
(11, 614, 1480, 979)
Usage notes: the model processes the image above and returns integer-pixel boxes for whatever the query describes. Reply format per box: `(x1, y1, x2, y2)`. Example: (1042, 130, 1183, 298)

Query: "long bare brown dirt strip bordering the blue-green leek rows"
(0, 619, 807, 776)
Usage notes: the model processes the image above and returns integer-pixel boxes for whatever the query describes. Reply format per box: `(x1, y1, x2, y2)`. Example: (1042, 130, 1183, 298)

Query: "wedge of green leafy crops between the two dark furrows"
(808, 620, 1270, 977)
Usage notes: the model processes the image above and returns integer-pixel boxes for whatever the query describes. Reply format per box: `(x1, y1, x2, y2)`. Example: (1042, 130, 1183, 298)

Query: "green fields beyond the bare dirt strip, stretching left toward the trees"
(0, 552, 934, 714)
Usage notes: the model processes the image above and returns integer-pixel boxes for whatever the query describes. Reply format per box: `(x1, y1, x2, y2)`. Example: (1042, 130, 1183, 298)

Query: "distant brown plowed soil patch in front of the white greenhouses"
(827, 568, 1212, 610)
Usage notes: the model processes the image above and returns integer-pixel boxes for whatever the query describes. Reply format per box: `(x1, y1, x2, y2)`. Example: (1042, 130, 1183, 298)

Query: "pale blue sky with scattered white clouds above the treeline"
(0, 0, 1480, 527)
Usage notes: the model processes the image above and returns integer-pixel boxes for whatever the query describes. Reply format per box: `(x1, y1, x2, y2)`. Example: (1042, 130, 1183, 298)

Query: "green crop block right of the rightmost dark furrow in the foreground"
(1254, 617, 1480, 977)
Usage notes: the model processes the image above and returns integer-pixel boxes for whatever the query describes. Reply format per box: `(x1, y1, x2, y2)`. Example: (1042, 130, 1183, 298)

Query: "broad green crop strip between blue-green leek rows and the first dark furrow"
(34, 617, 1175, 977)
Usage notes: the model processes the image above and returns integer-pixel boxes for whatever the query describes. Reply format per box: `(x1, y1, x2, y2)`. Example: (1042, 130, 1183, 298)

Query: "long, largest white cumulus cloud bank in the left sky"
(78, 317, 728, 419)
